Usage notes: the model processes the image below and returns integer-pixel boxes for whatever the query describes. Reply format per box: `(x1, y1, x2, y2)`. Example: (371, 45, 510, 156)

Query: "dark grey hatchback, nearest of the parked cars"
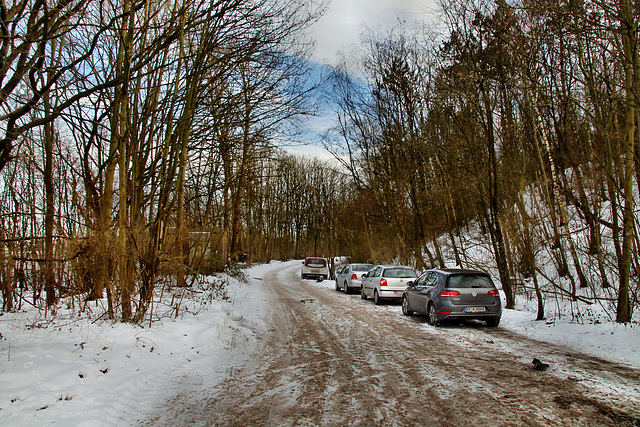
(402, 269, 502, 327)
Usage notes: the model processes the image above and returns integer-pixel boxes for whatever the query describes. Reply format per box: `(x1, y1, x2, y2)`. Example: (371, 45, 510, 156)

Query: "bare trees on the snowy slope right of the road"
(327, 0, 640, 322)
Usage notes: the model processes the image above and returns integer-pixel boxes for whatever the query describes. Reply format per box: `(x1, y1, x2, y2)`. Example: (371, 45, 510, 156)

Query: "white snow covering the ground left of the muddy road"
(0, 263, 277, 426)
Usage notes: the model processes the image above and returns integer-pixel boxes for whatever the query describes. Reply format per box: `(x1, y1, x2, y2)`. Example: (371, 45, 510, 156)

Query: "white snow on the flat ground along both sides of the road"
(0, 260, 640, 426)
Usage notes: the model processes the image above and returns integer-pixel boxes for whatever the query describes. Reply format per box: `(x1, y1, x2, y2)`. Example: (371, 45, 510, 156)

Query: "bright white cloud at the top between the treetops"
(313, 0, 435, 64)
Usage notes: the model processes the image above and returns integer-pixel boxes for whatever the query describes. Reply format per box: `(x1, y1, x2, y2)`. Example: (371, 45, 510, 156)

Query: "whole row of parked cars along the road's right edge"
(301, 258, 502, 327)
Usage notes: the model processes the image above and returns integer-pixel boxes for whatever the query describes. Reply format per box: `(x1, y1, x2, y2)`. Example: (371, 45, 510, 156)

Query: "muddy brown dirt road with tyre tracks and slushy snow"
(143, 266, 640, 426)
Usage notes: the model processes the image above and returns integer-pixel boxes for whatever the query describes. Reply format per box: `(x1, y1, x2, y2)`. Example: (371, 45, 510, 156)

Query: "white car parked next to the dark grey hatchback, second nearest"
(360, 265, 417, 305)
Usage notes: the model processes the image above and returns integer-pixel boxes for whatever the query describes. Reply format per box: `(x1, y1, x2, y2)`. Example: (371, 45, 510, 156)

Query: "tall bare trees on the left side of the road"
(0, 0, 338, 322)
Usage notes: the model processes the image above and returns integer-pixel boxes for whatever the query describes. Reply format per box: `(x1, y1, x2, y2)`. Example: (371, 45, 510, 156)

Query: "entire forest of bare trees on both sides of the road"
(0, 0, 640, 322)
